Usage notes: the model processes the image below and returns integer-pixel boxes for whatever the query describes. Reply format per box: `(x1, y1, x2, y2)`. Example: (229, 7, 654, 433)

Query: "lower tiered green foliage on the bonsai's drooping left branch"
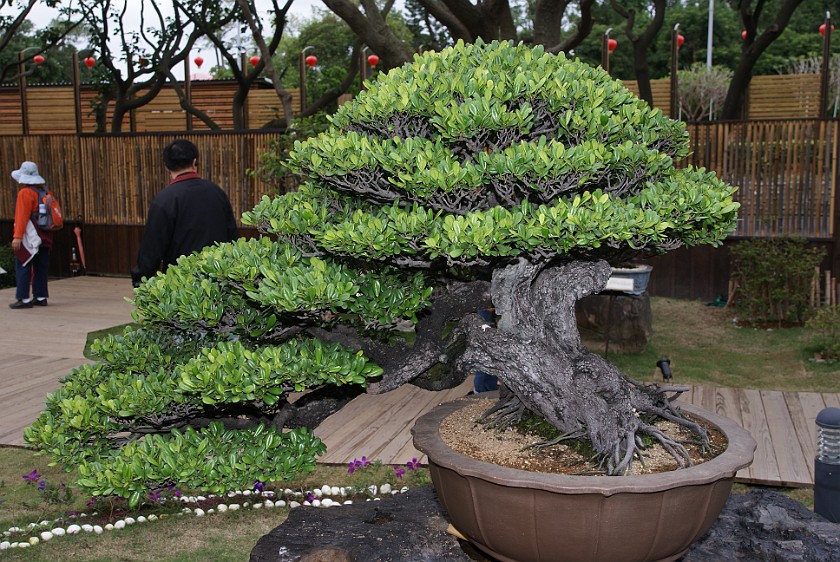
(25, 238, 414, 505)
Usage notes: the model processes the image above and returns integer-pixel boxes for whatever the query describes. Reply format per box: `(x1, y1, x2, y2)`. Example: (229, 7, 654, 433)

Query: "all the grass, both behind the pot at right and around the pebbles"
(0, 298, 840, 562)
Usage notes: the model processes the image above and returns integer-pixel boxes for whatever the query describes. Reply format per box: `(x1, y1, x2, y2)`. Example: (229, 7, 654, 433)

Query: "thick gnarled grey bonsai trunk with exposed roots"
(459, 259, 708, 474)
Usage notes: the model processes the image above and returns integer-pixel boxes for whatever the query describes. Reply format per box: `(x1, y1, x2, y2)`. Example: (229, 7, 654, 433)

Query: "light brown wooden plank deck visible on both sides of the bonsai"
(0, 277, 840, 487)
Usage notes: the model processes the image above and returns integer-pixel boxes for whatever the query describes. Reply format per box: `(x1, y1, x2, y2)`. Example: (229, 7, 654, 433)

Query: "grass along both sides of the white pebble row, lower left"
(0, 447, 429, 562)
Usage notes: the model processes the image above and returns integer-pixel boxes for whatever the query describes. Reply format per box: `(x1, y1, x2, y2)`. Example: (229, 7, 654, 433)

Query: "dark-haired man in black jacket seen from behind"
(131, 139, 238, 287)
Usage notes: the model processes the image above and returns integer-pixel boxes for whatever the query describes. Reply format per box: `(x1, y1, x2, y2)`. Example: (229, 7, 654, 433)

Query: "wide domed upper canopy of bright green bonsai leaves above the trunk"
(244, 38, 738, 265)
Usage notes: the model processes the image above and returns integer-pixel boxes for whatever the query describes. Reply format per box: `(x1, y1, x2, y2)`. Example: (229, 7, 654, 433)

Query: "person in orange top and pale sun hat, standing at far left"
(9, 162, 52, 309)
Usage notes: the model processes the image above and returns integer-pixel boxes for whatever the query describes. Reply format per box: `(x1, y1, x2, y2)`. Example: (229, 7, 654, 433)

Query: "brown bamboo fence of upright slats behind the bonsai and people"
(0, 119, 840, 240)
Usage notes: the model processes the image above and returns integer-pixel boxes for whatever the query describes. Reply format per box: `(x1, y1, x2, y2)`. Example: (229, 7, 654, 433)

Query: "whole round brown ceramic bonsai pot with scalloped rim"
(412, 400, 755, 562)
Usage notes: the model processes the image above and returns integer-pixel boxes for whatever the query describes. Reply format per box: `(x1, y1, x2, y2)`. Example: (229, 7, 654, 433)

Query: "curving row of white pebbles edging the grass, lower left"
(0, 483, 408, 550)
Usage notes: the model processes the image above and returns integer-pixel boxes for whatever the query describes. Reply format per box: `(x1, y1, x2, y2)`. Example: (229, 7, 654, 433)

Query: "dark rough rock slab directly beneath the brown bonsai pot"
(251, 487, 840, 562)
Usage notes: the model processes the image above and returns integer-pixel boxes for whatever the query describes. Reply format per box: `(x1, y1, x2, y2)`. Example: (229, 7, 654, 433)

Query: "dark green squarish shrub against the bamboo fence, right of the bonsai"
(730, 237, 825, 324)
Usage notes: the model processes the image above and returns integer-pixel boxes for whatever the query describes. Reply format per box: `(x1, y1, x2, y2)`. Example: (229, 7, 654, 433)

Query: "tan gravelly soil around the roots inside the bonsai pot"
(440, 398, 726, 475)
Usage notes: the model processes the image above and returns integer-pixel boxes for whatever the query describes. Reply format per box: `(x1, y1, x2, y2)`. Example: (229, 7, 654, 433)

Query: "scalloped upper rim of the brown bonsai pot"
(411, 396, 756, 496)
